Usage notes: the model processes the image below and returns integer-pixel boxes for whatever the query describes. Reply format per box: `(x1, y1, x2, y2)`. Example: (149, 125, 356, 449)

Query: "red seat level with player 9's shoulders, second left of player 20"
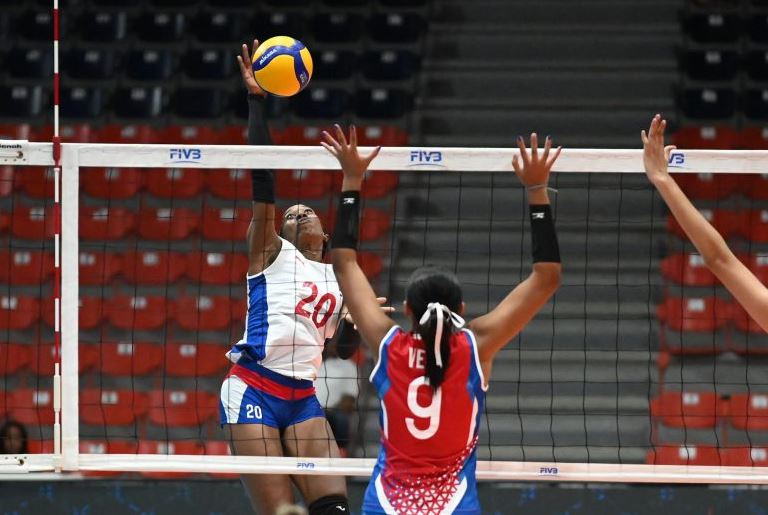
(99, 342, 164, 377)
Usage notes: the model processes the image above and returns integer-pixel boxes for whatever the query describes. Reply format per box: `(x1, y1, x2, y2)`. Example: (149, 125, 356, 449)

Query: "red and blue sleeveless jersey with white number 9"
(363, 327, 486, 514)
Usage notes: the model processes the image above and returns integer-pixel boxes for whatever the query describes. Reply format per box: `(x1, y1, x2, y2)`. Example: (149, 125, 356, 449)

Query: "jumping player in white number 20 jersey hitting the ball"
(220, 41, 373, 515)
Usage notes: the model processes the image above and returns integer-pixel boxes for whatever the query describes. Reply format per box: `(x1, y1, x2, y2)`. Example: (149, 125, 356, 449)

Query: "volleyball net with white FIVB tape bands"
(0, 141, 768, 483)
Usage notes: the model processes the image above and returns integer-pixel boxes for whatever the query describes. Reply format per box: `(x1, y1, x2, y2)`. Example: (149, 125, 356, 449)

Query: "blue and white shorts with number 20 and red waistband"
(219, 365, 325, 431)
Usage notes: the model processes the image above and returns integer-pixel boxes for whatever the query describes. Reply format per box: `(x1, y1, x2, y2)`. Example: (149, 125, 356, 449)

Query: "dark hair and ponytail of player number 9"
(406, 265, 462, 390)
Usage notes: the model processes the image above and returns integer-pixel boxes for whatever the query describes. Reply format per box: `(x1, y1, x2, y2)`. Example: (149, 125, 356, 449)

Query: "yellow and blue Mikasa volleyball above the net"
(252, 36, 312, 97)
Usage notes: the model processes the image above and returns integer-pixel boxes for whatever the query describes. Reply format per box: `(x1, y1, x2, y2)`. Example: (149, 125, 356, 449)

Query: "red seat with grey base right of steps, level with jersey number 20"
(657, 297, 730, 354)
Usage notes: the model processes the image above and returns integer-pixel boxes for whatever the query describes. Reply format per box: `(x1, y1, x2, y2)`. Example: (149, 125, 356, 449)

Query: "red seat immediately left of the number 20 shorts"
(149, 390, 219, 427)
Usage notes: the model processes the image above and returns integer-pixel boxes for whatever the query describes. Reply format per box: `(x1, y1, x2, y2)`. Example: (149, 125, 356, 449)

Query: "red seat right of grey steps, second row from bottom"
(651, 391, 720, 429)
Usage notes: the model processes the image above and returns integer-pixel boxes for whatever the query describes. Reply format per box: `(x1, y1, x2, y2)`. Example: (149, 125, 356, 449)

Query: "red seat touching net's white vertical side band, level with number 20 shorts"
(79, 388, 148, 427)
